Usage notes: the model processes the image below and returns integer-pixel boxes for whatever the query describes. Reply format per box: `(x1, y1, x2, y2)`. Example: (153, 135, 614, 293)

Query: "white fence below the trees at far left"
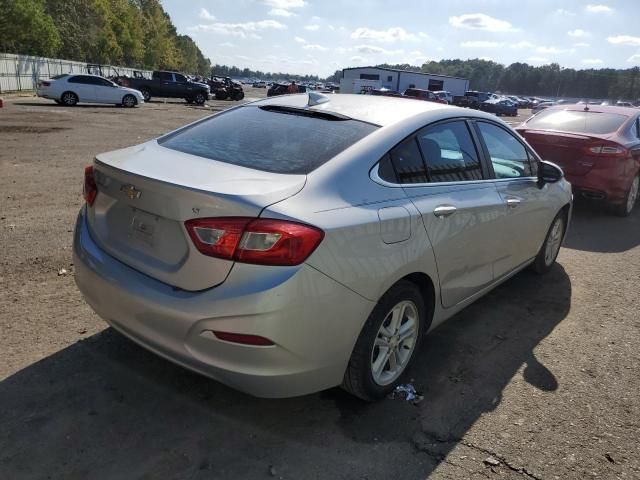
(0, 53, 151, 93)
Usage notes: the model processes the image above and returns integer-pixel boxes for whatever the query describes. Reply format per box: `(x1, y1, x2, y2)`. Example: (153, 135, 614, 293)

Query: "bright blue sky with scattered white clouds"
(163, 0, 640, 77)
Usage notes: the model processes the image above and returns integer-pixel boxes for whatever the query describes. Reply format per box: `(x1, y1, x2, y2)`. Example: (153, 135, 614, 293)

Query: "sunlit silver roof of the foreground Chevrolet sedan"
(247, 93, 456, 126)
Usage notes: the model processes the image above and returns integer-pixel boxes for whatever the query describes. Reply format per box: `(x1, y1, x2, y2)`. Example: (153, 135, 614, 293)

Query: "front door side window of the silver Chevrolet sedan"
(477, 122, 535, 178)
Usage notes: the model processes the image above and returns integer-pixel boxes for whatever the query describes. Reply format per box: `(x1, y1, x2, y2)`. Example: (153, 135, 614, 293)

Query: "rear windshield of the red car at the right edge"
(527, 110, 629, 134)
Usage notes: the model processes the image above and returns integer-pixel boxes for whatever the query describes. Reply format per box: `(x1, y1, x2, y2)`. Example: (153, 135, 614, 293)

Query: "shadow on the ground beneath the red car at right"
(564, 200, 640, 253)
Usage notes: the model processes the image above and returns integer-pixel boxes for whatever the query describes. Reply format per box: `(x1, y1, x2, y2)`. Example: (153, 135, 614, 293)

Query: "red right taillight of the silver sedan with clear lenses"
(185, 217, 324, 266)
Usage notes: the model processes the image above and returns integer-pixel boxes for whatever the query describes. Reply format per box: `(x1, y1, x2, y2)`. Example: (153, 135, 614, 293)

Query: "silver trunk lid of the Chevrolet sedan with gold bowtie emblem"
(88, 141, 306, 291)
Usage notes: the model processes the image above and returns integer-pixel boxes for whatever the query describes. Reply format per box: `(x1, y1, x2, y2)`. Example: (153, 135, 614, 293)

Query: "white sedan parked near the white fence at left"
(36, 73, 144, 108)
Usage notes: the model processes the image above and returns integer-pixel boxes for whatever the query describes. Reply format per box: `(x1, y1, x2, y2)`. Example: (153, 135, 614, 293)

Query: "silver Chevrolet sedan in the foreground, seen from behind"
(73, 93, 572, 400)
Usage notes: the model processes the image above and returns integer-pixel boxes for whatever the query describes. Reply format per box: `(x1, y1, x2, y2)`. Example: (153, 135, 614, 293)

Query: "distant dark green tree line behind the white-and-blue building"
(329, 59, 640, 100)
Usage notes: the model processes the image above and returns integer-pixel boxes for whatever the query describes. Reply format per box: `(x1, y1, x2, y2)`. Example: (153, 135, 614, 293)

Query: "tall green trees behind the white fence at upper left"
(0, 0, 211, 76)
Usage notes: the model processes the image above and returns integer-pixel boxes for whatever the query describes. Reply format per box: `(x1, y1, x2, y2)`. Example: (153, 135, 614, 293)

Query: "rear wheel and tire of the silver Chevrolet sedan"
(342, 280, 427, 401)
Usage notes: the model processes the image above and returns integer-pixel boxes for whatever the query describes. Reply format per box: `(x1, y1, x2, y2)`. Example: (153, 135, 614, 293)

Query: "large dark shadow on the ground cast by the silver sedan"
(0, 266, 571, 479)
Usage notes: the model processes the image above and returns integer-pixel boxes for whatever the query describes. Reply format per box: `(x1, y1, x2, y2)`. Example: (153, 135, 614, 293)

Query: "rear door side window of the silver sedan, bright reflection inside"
(417, 121, 482, 182)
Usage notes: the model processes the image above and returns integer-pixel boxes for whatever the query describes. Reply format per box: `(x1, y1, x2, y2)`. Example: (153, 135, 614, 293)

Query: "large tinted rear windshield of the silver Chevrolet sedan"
(158, 106, 378, 174)
